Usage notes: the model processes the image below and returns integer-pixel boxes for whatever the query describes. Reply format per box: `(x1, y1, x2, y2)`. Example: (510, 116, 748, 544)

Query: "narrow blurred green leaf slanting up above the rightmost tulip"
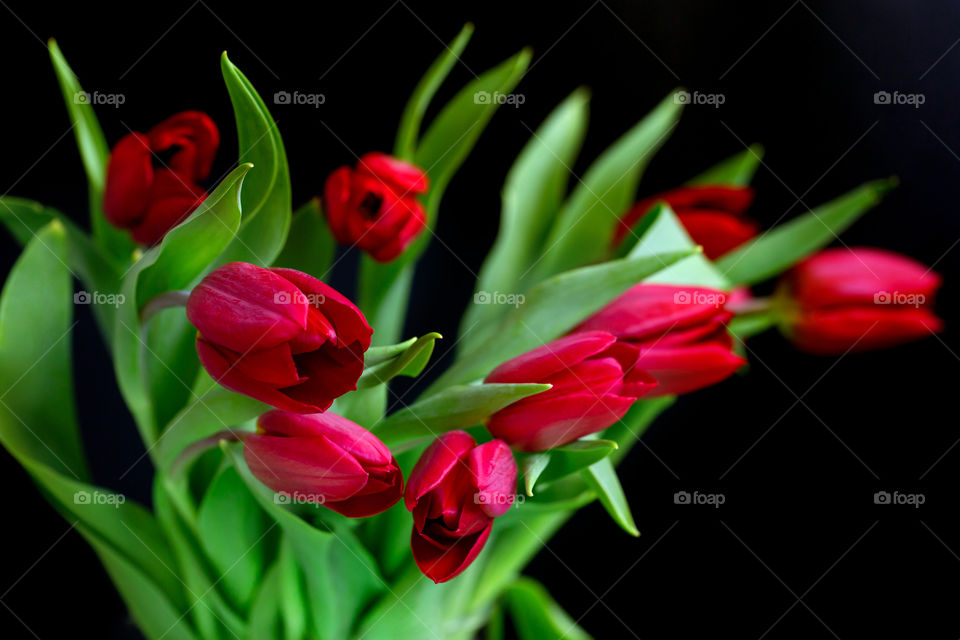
(716, 178, 896, 284)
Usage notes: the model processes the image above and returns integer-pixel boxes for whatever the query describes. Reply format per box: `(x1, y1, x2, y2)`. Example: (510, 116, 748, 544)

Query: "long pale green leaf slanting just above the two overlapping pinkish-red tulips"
(426, 250, 693, 394)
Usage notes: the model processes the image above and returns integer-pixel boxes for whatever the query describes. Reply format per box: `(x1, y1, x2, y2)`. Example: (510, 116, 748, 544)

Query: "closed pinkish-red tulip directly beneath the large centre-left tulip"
(243, 410, 403, 518)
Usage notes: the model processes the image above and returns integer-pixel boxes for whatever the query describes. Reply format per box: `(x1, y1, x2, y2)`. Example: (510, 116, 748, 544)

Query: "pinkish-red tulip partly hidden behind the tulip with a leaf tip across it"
(572, 283, 746, 397)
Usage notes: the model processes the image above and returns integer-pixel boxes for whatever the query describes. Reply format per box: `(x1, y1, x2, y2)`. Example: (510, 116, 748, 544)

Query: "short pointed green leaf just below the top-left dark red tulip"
(137, 164, 253, 308)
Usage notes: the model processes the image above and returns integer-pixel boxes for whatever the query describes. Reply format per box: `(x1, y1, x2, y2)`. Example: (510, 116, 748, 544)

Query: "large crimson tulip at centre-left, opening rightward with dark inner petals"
(187, 262, 373, 413)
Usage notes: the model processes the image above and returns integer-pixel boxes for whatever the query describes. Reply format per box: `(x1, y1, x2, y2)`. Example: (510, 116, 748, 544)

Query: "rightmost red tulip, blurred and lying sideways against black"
(779, 248, 943, 355)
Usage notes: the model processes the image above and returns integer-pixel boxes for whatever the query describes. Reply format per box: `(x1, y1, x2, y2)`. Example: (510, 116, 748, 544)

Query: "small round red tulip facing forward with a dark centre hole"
(323, 153, 427, 262)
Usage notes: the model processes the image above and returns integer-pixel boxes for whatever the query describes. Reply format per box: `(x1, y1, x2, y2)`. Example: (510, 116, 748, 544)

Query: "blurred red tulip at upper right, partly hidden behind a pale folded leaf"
(613, 185, 757, 260)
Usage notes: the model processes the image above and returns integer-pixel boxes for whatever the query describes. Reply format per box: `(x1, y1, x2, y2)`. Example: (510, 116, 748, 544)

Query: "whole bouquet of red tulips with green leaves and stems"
(0, 26, 941, 640)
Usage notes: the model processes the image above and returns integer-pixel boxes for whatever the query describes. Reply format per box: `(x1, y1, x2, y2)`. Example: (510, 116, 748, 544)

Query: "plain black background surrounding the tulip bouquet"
(0, 0, 960, 640)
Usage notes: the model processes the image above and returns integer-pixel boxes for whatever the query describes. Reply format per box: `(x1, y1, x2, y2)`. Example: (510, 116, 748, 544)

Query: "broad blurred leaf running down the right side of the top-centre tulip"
(358, 50, 530, 344)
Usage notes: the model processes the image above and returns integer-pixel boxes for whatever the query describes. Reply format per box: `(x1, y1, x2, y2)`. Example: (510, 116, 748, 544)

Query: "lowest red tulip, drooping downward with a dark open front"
(403, 431, 517, 583)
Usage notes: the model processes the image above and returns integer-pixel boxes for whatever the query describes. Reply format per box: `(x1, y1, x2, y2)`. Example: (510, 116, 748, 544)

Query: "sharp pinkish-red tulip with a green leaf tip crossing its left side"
(484, 331, 657, 451)
